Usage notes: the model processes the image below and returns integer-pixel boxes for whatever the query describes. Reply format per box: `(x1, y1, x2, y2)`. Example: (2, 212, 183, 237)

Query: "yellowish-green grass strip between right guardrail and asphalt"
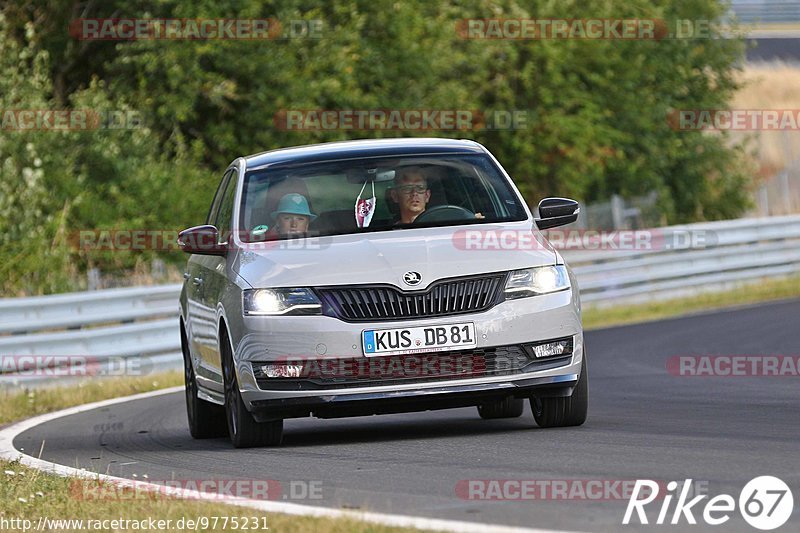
(583, 276, 800, 329)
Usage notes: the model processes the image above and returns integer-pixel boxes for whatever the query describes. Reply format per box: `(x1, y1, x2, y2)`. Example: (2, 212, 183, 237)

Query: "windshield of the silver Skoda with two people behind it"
(240, 154, 527, 242)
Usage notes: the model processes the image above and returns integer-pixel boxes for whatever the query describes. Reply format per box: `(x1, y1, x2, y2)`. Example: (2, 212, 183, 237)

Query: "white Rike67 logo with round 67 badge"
(622, 476, 794, 531)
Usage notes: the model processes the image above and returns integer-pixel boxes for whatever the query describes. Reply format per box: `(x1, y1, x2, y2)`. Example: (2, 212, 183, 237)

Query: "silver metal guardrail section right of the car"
(562, 215, 800, 307)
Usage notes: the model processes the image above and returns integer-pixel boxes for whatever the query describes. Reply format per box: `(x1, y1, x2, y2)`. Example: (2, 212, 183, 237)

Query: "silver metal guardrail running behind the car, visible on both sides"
(0, 215, 800, 385)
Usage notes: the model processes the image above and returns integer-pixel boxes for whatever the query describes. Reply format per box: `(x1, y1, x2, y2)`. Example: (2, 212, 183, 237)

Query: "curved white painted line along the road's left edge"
(0, 386, 566, 533)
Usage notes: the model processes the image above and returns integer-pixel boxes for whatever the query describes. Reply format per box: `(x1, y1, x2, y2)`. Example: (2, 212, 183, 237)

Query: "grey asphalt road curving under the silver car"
(15, 300, 800, 531)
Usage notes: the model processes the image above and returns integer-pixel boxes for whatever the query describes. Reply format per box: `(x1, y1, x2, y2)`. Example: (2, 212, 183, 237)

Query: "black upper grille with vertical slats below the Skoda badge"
(317, 272, 506, 322)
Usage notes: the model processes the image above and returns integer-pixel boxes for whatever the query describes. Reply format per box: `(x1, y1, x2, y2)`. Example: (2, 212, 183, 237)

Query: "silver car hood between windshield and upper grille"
(234, 222, 556, 290)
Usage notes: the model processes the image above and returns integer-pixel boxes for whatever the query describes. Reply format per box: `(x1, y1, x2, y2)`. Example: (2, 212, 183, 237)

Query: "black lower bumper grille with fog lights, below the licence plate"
(253, 345, 571, 390)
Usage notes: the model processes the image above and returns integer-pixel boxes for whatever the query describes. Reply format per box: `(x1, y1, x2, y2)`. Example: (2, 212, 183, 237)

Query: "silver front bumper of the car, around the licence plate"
(235, 290, 583, 420)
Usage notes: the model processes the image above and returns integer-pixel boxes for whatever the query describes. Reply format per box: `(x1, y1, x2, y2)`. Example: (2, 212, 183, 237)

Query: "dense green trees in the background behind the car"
(0, 0, 752, 291)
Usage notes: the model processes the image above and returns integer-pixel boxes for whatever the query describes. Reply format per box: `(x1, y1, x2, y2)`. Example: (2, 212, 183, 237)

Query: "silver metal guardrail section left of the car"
(0, 285, 181, 386)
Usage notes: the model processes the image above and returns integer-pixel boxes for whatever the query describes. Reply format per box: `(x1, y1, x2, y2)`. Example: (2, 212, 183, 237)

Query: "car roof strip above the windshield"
(244, 138, 486, 170)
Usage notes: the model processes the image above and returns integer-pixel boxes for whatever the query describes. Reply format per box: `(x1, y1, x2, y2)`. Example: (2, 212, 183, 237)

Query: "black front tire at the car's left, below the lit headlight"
(220, 330, 283, 448)
